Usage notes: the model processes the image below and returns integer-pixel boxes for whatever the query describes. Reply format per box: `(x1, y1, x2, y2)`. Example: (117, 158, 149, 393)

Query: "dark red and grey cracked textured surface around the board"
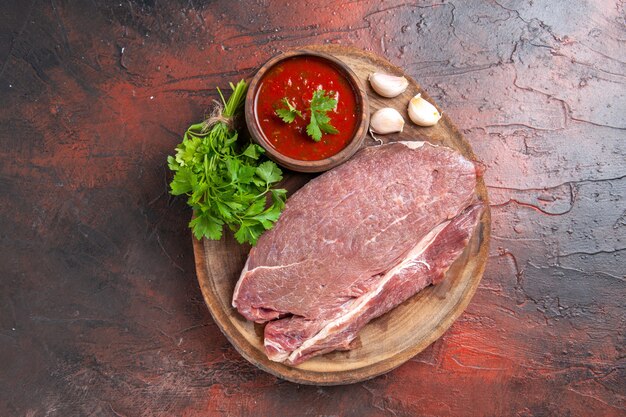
(0, 0, 626, 416)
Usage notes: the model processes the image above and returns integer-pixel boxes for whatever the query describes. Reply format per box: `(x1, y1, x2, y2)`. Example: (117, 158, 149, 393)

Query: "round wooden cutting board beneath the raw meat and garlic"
(193, 45, 491, 385)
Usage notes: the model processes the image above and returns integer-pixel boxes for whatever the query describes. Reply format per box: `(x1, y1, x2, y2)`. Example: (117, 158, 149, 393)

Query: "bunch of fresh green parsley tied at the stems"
(167, 80, 287, 245)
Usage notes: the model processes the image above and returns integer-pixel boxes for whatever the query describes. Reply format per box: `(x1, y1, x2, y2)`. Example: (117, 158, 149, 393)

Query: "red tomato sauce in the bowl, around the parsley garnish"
(255, 56, 357, 161)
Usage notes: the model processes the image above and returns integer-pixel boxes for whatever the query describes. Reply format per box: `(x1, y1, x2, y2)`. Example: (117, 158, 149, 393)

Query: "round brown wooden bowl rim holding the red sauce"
(245, 49, 370, 172)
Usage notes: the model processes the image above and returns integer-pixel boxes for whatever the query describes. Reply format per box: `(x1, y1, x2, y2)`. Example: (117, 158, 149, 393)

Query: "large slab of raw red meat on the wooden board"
(233, 142, 483, 364)
